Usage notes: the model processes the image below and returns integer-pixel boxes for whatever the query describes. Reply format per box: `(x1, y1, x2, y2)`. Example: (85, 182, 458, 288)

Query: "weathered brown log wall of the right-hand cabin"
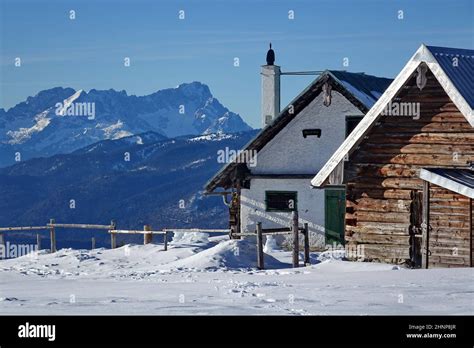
(345, 71, 474, 265)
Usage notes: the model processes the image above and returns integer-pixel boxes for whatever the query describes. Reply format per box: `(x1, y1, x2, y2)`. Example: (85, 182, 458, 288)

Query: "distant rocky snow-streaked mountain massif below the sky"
(0, 82, 251, 166)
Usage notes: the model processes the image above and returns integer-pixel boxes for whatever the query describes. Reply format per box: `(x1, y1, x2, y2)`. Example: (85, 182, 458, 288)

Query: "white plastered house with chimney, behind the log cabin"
(205, 46, 392, 245)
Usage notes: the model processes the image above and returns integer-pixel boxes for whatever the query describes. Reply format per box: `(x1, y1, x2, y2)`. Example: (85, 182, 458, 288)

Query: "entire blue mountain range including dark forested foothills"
(0, 82, 256, 247)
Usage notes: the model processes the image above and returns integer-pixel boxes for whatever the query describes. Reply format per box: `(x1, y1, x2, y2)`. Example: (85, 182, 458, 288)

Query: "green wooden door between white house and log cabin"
(324, 187, 346, 245)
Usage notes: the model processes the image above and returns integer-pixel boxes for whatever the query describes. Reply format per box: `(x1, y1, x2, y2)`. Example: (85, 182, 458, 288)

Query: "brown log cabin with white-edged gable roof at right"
(311, 45, 474, 267)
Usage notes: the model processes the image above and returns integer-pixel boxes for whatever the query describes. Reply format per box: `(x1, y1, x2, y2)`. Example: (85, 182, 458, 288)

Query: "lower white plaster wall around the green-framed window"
(240, 179, 324, 243)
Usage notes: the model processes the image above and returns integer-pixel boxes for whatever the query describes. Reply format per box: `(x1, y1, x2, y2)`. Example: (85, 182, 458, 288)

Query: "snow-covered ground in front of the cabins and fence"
(0, 234, 474, 315)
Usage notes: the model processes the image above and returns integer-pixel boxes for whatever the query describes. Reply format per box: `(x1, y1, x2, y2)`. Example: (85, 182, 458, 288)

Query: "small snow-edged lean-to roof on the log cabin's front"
(420, 168, 474, 198)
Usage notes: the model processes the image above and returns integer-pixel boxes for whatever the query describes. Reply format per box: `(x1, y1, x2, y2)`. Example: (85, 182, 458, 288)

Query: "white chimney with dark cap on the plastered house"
(261, 44, 281, 127)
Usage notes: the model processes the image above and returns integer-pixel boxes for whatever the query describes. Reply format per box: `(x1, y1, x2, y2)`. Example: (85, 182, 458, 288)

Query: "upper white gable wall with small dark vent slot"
(254, 91, 363, 175)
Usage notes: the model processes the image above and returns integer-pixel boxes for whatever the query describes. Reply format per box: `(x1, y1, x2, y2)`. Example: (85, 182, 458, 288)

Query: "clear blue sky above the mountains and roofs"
(0, 0, 474, 127)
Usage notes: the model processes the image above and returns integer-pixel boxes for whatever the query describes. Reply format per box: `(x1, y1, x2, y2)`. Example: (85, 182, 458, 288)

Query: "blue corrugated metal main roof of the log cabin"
(427, 46, 474, 109)
